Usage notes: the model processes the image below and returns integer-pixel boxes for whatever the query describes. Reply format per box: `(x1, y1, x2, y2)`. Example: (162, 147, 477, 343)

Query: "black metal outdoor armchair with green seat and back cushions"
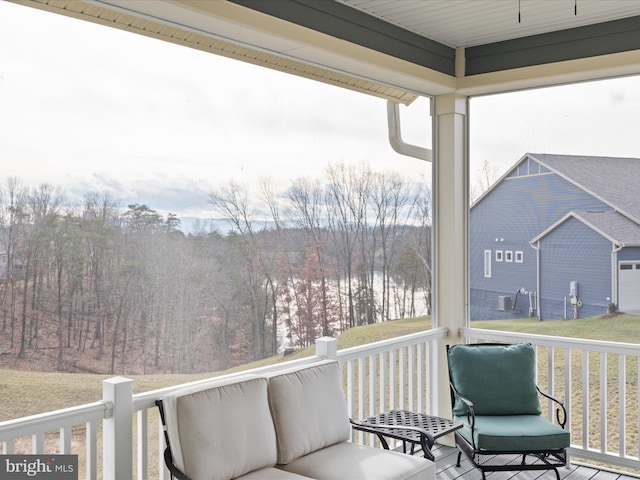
(447, 343, 570, 480)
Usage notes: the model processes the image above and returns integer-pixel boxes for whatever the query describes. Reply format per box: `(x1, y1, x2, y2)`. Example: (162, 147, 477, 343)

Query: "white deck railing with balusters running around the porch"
(0, 328, 640, 480)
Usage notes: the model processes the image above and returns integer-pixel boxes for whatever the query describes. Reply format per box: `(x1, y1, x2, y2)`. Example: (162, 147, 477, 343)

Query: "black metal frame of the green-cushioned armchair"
(447, 343, 567, 480)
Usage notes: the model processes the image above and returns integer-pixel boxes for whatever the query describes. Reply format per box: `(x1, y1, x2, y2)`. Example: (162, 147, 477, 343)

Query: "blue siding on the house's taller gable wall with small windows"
(469, 159, 611, 320)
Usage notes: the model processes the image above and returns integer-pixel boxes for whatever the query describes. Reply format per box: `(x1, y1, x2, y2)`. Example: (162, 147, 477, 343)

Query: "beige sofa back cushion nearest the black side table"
(269, 360, 351, 464)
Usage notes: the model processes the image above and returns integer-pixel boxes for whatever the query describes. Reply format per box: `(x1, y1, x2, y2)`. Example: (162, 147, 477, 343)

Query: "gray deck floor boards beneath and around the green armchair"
(433, 444, 640, 480)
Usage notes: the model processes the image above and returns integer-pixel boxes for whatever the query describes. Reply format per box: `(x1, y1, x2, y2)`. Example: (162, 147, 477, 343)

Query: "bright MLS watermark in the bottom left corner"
(0, 455, 78, 480)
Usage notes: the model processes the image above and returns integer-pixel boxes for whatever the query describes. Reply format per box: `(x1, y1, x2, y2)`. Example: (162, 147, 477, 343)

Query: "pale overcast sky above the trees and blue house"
(0, 1, 640, 228)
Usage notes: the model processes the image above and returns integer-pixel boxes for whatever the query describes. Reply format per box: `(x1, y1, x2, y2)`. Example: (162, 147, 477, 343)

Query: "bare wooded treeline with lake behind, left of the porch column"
(0, 164, 431, 374)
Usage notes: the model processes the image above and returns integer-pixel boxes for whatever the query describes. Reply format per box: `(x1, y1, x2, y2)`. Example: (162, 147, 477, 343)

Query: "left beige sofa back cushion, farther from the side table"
(163, 375, 276, 480)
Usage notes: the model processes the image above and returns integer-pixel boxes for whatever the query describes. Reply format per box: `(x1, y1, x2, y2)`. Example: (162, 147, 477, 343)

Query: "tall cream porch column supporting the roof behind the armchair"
(433, 94, 469, 416)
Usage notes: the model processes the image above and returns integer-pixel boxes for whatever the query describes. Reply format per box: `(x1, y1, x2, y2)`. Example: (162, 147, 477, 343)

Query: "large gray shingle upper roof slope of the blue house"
(527, 153, 640, 223)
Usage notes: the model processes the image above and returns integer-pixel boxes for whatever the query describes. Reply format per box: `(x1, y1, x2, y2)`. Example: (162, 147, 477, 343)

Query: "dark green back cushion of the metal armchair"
(448, 343, 541, 416)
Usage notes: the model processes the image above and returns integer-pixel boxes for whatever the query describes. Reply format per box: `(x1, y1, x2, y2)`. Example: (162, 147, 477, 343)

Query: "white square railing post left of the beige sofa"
(102, 377, 133, 480)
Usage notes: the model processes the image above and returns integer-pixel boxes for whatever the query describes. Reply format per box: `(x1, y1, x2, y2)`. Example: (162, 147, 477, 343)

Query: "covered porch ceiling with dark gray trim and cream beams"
(9, 0, 640, 104)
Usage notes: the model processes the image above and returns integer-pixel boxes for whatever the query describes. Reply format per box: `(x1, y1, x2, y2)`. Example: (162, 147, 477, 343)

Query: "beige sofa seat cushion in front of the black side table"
(279, 442, 436, 480)
